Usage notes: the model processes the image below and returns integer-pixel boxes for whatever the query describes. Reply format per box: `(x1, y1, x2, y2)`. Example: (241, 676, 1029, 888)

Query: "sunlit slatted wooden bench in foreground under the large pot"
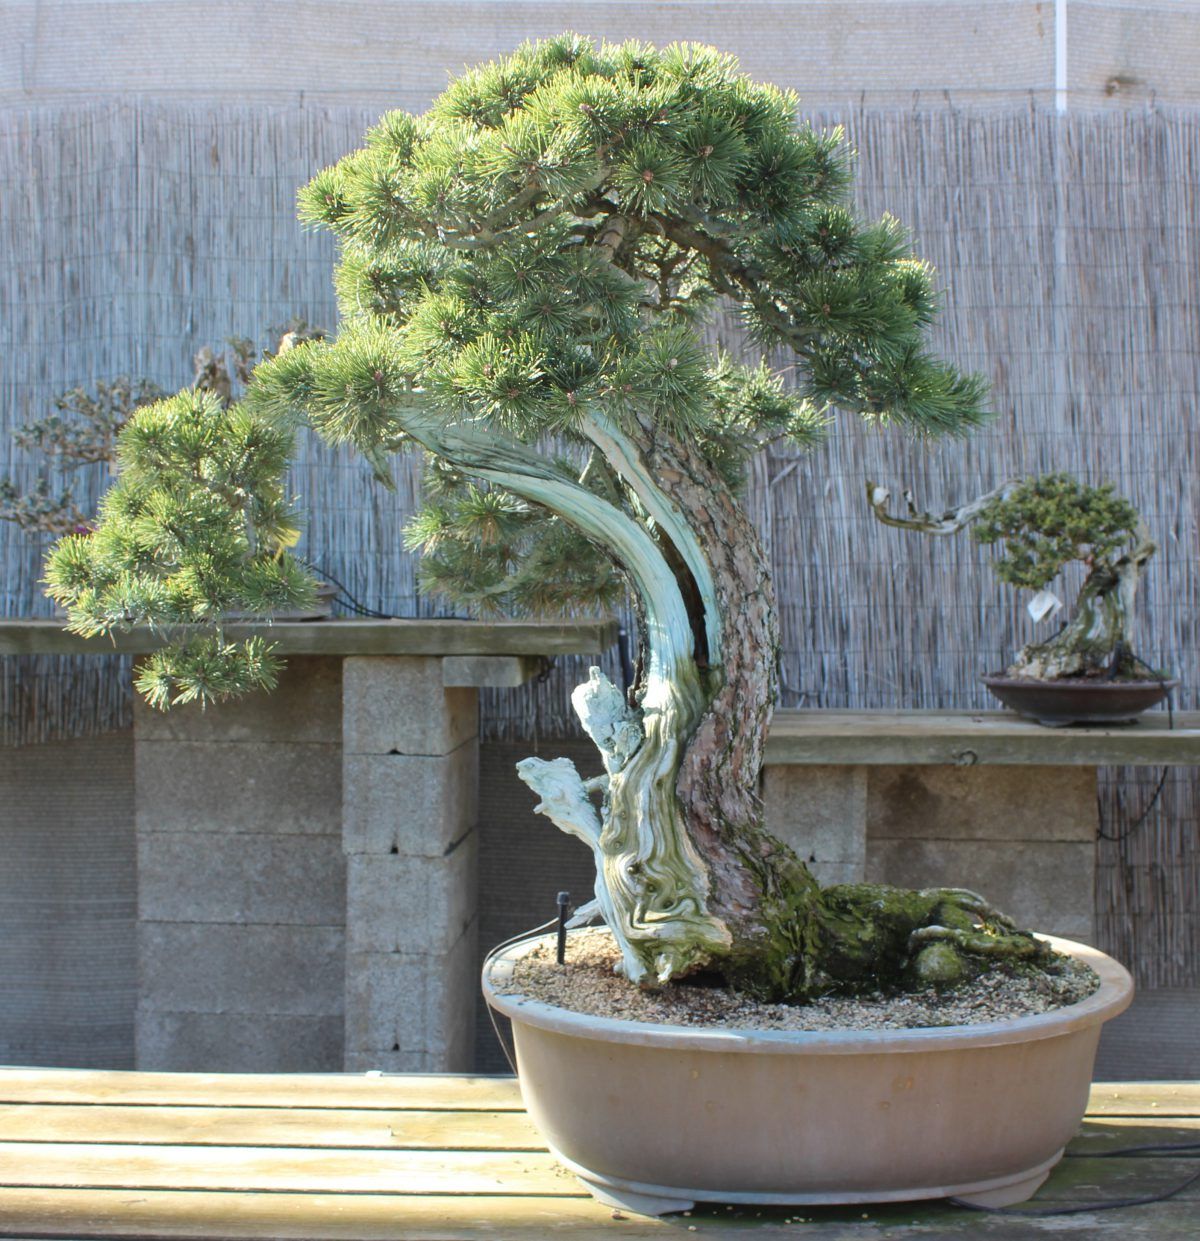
(0, 1069, 1200, 1241)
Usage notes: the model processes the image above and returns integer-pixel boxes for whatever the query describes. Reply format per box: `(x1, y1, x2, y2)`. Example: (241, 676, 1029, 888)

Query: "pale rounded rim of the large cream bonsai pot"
(483, 934, 1133, 1055)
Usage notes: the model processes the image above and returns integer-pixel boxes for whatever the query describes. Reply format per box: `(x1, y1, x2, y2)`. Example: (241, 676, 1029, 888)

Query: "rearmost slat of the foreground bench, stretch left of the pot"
(0, 1069, 521, 1112)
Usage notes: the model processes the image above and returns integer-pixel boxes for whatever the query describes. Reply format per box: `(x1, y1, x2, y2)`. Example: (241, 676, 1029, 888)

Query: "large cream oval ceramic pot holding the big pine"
(483, 938, 1133, 1214)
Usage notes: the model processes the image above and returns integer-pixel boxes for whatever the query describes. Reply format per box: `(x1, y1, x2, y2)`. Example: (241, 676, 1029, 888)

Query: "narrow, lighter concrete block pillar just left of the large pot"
(343, 655, 479, 1072)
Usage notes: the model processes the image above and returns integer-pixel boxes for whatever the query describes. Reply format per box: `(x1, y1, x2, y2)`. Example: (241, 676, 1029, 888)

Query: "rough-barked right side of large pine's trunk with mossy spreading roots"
(583, 416, 1044, 1000)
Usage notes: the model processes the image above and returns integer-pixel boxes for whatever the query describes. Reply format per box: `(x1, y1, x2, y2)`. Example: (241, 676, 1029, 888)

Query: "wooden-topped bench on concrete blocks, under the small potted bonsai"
(763, 711, 1200, 942)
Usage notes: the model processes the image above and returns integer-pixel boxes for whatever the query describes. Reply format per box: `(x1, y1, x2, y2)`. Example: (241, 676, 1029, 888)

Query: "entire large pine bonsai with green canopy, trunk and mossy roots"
(48, 35, 1042, 999)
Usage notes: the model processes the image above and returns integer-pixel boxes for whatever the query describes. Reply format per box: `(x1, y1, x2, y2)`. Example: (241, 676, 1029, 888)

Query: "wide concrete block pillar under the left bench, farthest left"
(134, 656, 345, 1072)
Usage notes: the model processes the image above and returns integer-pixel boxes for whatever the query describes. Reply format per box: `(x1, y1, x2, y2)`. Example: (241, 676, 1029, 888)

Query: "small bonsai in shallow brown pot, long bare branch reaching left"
(866, 474, 1178, 726)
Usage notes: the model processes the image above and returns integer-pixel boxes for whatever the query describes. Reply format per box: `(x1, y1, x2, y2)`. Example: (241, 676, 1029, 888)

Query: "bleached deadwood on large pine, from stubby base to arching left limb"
(397, 393, 732, 982)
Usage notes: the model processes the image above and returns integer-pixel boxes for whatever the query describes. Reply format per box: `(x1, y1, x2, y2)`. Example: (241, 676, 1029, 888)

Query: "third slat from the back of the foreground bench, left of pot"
(0, 1142, 582, 1195)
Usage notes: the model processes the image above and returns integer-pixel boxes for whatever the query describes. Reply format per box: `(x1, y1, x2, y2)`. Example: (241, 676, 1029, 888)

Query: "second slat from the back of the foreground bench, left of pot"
(0, 1103, 546, 1150)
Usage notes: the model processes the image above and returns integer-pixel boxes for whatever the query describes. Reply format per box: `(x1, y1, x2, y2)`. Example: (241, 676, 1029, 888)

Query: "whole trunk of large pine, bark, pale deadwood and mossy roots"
(401, 405, 1041, 999)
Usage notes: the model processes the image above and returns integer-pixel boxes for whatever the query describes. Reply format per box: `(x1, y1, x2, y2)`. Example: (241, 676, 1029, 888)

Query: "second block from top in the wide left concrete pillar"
(134, 741, 341, 836)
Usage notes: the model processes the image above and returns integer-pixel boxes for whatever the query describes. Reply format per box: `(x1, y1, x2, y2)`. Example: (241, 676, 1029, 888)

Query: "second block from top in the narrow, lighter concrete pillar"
(343, 738, 479, 858)
